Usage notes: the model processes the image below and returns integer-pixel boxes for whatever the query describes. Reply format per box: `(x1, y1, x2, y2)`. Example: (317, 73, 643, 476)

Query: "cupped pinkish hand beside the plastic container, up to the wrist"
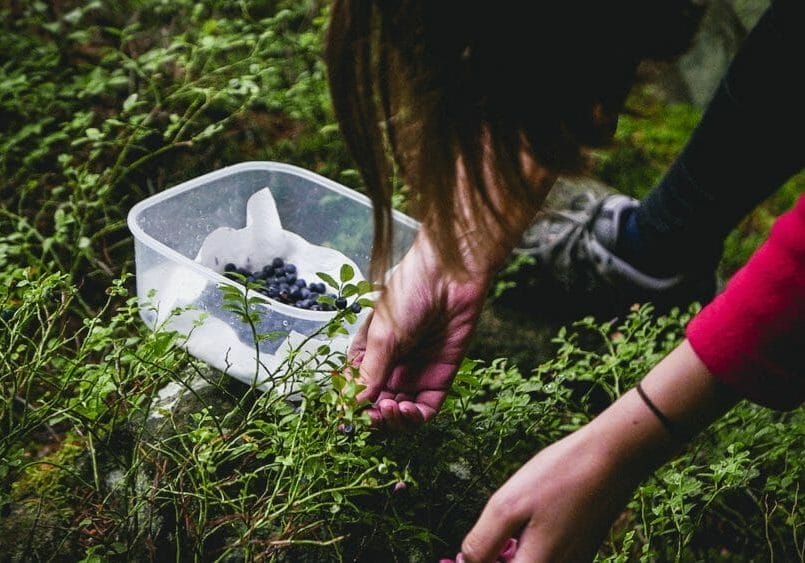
(349, 235, 491, 430)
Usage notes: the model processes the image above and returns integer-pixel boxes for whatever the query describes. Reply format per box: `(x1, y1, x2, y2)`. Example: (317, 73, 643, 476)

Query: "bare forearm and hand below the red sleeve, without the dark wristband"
(456, 341, 737, 563)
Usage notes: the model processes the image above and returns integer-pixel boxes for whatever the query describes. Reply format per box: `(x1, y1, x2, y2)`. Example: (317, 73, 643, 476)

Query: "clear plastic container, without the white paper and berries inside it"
(128, 162, 419, 388)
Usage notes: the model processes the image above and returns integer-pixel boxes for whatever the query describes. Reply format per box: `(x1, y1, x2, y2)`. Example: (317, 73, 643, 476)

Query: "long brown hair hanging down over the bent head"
(326, 0, 702, 280)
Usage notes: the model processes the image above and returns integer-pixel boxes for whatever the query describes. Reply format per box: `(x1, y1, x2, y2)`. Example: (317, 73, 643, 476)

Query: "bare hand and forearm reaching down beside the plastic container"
(348, 148, 555, 430)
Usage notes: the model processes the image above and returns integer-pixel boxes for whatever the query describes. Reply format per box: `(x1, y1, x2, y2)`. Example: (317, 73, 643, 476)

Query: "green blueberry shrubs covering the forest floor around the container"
(0, 0, 805, 562)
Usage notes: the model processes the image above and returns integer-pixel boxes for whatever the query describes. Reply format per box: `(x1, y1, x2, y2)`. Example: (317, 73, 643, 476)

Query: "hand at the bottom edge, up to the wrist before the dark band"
(456, 431, 646, 563)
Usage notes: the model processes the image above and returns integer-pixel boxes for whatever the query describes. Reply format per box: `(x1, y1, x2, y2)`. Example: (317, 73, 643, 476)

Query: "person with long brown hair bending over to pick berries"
(326, 0, 805, 561)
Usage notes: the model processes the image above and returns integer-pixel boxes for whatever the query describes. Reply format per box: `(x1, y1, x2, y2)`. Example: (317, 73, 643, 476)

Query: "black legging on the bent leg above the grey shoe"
(627, 0, 805, 273)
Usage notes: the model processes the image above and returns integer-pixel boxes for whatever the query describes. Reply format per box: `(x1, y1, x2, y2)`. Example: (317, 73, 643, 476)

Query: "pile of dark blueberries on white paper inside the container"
(224, 257, 361, 313)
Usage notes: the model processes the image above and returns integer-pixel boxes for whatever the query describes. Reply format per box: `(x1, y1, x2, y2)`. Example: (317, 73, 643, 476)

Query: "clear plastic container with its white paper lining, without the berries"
(129, 162, 418, 393)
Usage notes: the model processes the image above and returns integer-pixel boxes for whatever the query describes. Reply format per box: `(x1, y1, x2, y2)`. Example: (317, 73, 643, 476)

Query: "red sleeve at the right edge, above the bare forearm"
(687, 196, 805, 410)
